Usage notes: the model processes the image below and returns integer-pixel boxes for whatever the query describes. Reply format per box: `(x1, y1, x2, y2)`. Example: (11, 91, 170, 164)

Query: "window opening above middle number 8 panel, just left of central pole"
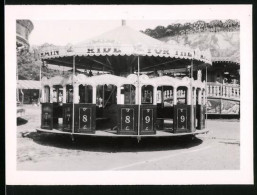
(121, 85, 136, 104)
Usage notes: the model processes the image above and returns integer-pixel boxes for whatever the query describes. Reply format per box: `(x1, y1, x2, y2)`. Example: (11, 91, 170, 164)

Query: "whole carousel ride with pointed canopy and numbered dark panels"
(37, 22, 211, 137)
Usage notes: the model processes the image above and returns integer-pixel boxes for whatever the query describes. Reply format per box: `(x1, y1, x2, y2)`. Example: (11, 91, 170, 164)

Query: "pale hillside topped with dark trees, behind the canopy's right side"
(142, 19, 240, 63)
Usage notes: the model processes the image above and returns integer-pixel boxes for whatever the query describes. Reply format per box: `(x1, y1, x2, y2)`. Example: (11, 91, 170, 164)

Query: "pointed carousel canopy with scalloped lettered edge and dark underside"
(41, 22, 211, 73)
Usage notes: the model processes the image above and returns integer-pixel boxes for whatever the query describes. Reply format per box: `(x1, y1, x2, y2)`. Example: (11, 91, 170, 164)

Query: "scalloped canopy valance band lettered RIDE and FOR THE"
(40, 42, 211, 62)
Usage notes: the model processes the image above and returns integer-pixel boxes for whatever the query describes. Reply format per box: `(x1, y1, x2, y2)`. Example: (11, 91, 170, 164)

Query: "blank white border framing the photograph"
(5, 5, 253, 185)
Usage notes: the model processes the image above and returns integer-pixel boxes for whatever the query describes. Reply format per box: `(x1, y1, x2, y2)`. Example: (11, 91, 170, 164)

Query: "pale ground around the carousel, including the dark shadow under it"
(17, 106, 240, 171)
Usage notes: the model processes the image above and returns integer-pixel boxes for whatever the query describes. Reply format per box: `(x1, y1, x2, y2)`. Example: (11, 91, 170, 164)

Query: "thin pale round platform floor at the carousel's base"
(36, 128, 209, 137)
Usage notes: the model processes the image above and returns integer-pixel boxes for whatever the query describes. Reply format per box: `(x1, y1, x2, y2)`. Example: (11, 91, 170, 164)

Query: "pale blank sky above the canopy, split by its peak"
(29, 20, 200, 46)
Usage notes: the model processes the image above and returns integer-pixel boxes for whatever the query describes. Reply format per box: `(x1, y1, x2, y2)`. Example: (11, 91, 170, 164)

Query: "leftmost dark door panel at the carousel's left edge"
(41, 103, 53, 130)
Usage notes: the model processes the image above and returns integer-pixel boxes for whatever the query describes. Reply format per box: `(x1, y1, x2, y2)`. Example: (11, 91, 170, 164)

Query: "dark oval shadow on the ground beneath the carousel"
(23, 132, 202, 153)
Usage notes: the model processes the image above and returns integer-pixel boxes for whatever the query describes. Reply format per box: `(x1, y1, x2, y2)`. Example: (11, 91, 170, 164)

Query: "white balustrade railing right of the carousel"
(207, 82, 240, 100)
